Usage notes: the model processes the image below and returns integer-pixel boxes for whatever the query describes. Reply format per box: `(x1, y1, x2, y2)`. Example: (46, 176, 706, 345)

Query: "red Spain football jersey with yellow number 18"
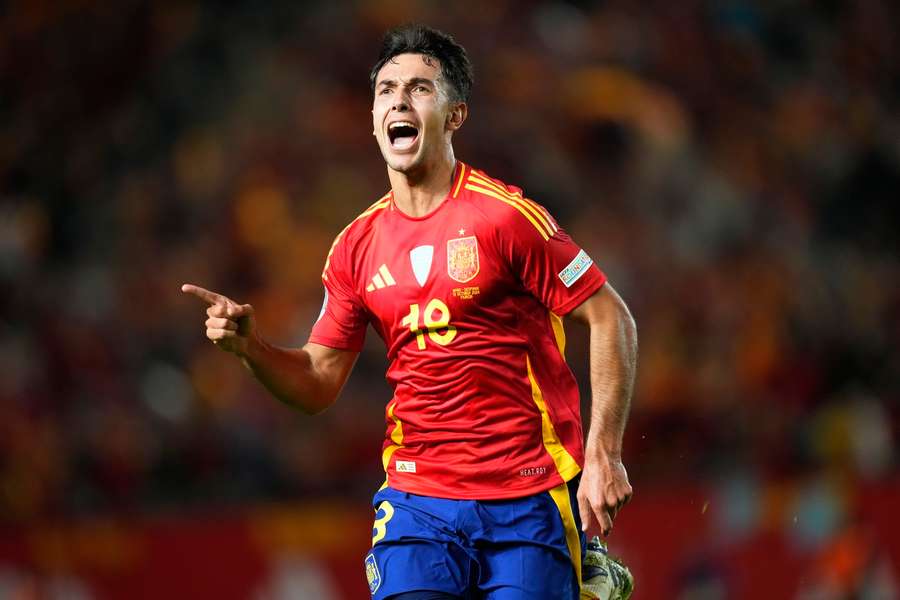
(309, 163, 606, 500)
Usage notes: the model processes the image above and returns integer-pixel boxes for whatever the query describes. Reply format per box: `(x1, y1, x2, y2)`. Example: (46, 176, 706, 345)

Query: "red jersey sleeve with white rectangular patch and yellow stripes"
(502, 200, 606, 315)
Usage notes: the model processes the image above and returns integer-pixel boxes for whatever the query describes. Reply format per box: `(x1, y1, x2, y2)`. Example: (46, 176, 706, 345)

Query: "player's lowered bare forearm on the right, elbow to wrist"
(585, 295, 637, 459)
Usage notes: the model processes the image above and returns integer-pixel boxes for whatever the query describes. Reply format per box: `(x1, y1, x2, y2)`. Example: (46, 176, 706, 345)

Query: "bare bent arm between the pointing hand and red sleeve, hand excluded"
(241, 338, 359, 415)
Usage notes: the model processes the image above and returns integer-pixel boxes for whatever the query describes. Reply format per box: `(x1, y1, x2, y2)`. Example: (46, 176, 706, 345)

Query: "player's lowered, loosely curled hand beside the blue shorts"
(578, 457, 633, 537)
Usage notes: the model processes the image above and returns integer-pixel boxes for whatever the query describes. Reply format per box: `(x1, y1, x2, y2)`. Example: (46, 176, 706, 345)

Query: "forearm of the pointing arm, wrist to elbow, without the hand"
(240, 338, 340, 414)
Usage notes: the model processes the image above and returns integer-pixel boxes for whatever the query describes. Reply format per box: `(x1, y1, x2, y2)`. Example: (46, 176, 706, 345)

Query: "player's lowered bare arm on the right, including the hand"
(570, 283, 637, 535)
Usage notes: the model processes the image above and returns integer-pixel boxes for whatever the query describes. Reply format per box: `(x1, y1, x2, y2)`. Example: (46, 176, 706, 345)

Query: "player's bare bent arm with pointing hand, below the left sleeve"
(181, 284, 359, 414)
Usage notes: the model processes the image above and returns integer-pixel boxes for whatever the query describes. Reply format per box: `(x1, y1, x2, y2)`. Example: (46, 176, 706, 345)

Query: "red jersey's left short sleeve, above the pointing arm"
(309, 231, 369, 352)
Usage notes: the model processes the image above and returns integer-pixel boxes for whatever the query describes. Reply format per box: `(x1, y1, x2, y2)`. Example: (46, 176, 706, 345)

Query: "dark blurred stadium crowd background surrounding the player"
(0, 0, 900, 600)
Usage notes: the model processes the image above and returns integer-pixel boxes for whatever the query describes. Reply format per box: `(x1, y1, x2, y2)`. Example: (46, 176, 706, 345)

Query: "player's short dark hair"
(369, 24, 474, 102)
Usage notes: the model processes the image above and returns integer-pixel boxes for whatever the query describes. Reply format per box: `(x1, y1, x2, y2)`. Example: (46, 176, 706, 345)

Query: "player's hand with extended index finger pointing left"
(181, 283, 257, 357)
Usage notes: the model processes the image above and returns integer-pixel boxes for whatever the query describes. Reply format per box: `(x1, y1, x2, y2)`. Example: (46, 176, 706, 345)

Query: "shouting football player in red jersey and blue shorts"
(182, 26, 637, 600)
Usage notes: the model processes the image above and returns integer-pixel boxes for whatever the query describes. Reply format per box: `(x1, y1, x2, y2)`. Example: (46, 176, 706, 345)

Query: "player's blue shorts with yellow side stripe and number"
(365, 477, 585, 600)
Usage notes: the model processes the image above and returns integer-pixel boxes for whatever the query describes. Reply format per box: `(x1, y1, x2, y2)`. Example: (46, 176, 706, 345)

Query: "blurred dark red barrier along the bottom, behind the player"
(0, 483, 900, 600)
